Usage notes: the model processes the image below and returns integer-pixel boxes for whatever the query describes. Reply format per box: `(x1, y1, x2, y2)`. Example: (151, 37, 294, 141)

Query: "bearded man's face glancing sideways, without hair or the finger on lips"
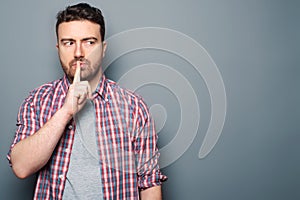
(57, 20, 106, 84)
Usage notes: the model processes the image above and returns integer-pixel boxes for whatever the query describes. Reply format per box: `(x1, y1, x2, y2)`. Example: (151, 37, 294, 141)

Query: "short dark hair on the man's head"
(56, 3, 105, 41)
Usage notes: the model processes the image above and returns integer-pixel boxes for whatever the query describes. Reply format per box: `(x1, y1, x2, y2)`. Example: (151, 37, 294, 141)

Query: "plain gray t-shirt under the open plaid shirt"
(63, 100, 103, 200)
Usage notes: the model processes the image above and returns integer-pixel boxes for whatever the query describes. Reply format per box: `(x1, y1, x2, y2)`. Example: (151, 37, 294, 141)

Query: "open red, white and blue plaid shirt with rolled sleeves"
(7, 75, 167, 200)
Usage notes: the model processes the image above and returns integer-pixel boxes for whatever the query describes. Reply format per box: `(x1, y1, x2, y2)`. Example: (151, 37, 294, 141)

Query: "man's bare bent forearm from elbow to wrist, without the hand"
(11, 108, 70, 178)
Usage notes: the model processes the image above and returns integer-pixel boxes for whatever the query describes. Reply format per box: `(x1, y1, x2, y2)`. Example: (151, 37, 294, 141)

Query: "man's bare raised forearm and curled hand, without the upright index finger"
(10, 71, 91, 178)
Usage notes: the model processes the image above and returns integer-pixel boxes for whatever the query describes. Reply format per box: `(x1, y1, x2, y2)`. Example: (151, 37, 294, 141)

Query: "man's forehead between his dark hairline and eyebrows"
(58, 20, 100, 39)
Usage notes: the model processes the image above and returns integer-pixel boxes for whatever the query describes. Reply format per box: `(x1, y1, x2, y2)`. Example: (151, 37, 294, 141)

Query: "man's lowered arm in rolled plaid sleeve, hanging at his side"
(136, 98, 167, 197)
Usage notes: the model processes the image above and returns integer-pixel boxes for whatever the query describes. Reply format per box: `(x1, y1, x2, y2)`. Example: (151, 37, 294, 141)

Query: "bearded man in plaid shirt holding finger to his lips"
(7, 3, 167, 200)
